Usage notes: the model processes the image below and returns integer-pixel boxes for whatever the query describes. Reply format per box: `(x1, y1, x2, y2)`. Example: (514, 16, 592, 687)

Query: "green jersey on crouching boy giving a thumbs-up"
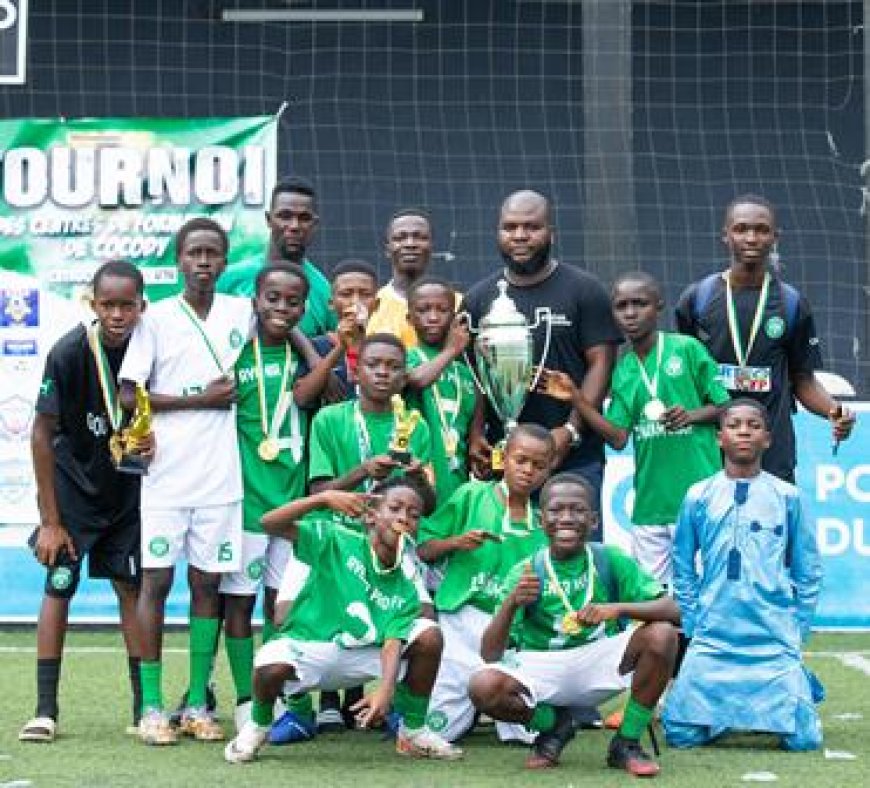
(499, 545, 665, 651)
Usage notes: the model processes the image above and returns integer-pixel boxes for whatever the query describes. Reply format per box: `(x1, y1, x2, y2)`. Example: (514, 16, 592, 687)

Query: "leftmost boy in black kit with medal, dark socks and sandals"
(18, 261, 152, 742)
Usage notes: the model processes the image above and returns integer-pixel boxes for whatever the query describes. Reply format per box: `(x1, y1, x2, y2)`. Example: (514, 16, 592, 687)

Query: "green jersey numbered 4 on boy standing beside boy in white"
(235, 342, 308, 533)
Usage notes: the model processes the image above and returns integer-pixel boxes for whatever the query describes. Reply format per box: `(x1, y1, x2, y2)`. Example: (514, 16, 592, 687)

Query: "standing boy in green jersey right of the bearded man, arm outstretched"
(539, 271, 728, 586)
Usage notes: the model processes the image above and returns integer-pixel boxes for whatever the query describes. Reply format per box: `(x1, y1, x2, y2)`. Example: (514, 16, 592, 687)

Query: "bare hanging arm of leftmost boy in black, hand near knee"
(30, 413, 77, 566)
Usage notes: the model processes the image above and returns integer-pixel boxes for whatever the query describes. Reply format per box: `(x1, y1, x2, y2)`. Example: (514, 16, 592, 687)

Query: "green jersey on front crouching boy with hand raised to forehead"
(280, 512, 421, 648)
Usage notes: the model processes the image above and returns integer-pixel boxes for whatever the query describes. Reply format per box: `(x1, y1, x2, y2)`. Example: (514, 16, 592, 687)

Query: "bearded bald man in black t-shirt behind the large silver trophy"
(463, 190, 621, 520)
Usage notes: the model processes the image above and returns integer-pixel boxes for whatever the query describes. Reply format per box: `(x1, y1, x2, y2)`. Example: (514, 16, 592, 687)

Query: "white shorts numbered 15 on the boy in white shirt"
(142, 501, 242, 573)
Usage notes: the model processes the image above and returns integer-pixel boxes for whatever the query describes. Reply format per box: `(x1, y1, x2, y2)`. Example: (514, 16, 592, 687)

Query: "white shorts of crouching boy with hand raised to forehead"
(254, 618, 438, 694)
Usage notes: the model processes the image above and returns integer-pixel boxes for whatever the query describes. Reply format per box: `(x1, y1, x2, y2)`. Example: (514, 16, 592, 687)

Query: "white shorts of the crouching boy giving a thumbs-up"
(479, 630, 634, 708)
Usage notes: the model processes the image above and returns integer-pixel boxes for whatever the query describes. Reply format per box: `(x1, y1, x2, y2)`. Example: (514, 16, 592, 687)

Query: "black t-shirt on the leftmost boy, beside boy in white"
(36, 325, 139, 511)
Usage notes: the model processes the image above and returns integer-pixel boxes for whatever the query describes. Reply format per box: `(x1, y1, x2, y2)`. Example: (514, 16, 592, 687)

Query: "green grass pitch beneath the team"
(0, 630, 870, 788)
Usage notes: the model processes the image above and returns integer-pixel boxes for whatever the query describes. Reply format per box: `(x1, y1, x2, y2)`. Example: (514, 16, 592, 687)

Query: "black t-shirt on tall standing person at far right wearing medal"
(676, 270, 822, 481)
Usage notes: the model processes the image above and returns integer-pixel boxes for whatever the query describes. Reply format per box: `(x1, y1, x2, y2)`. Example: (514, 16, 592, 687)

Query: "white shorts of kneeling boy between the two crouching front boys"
(426, 605, 534, 744)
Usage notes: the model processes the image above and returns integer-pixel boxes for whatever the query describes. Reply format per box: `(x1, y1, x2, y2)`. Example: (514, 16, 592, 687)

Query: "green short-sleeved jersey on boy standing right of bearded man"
(606, 332, 728, 525)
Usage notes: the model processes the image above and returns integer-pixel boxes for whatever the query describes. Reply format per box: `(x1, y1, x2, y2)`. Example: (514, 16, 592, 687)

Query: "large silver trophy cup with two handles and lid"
(468, 279, 553, 470)
